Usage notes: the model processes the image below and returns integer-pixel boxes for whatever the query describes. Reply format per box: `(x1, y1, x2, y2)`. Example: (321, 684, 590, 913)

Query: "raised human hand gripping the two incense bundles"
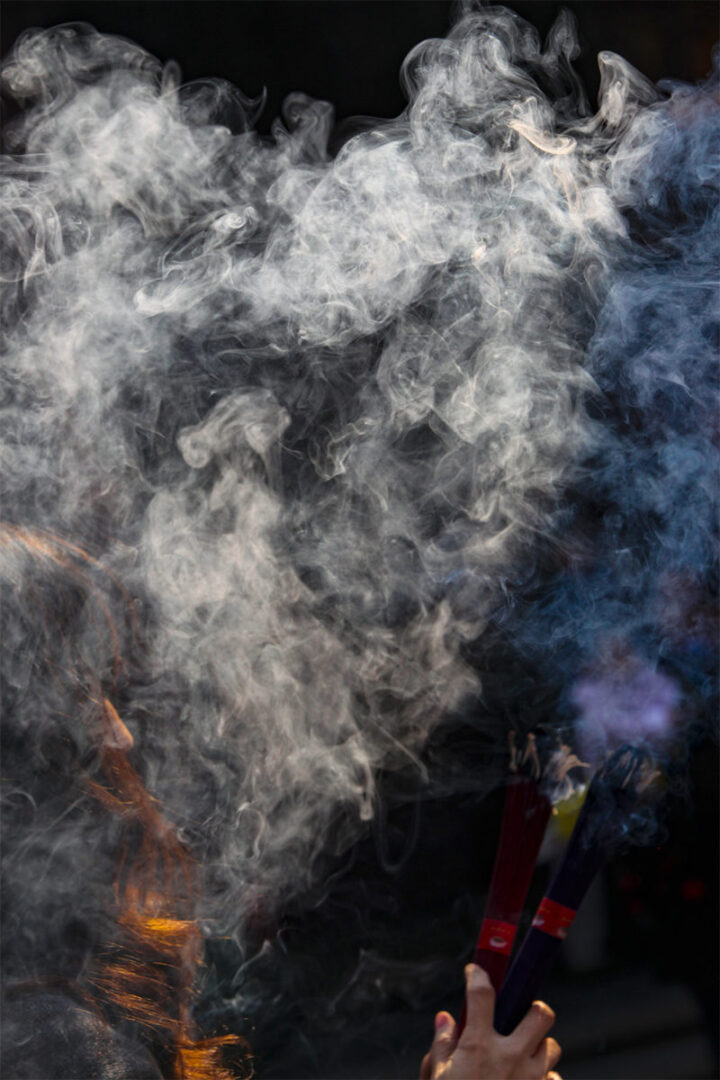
(420, 963, 561, 1080)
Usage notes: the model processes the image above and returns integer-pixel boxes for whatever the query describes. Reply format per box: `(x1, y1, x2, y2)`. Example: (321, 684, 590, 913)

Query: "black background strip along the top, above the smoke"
(1, 0, 718, 131)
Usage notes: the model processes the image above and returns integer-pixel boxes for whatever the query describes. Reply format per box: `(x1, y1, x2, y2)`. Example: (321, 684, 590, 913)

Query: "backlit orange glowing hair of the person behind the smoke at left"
(0, 525, 253, 1080)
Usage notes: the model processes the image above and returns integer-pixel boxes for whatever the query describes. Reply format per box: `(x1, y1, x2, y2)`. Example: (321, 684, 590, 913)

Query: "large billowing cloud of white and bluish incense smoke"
(2, 0, 720, 1045)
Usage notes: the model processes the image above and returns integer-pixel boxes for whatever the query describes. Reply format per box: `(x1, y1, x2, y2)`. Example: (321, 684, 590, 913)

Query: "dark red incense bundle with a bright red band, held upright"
(458, 733, 551, 1035)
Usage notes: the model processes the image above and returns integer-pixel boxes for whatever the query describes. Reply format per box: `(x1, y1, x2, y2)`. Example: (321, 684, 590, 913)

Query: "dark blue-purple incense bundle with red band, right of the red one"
(494, 746, 646, 1035)
